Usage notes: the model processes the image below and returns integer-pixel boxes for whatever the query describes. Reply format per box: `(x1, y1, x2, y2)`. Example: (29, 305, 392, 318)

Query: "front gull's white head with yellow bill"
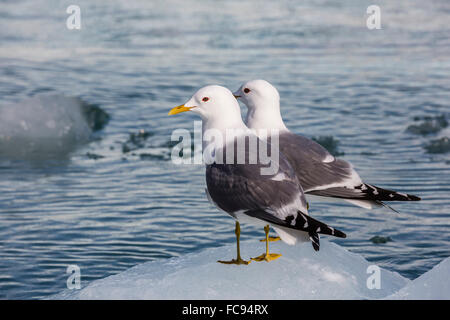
(169, 85, 243, 128)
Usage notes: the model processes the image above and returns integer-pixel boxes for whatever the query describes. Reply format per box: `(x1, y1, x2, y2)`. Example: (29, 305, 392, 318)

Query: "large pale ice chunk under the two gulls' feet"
(53, 239, 410, 299)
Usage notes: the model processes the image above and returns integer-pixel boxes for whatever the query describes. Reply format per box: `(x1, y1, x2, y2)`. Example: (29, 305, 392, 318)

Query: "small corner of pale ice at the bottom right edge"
(387, 257, 450, 300)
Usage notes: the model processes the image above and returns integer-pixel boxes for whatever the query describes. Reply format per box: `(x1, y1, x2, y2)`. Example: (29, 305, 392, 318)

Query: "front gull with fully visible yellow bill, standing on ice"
(169, 85, 345, 264)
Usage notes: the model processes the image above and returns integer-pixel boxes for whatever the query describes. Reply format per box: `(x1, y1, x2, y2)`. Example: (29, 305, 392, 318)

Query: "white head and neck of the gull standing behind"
(233, 80, 287, 130)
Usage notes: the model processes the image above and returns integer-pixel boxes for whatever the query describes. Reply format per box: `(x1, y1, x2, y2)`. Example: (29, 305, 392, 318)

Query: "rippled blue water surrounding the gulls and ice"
(0, 0, 450, 299)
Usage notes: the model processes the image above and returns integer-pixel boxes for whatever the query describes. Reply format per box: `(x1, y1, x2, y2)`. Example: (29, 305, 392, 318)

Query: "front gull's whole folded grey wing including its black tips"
(206, 138, 345, 238)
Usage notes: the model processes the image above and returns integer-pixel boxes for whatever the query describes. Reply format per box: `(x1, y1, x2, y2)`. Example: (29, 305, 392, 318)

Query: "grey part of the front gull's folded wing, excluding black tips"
(206, 142, 308, 220)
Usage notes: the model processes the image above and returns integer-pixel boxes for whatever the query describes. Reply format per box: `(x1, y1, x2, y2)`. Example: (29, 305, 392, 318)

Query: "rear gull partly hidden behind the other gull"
(233, 80, 420, 209)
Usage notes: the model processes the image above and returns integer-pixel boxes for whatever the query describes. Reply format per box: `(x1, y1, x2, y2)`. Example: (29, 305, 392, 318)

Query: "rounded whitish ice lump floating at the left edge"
(0, 94, 92, 158)
